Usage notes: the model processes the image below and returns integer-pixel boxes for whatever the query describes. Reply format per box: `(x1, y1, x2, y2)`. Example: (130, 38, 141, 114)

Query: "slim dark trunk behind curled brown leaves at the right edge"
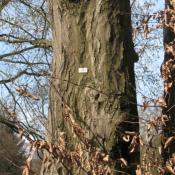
(163, 0, 175, 160)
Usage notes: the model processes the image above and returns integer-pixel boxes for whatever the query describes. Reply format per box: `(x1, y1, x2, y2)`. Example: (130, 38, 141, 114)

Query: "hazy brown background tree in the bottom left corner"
(0, 124, 26, 175)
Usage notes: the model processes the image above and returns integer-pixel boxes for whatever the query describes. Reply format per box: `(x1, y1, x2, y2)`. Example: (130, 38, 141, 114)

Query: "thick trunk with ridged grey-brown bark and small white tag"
(41, 0, 139, 175)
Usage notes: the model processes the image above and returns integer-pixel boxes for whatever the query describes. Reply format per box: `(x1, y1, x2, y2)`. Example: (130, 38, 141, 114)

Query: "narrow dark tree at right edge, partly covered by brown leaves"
(162, 0, 175, 165)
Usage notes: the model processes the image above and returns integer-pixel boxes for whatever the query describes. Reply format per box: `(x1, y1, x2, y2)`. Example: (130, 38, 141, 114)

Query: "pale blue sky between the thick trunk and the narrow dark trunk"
(135, 0, 164, 103)
